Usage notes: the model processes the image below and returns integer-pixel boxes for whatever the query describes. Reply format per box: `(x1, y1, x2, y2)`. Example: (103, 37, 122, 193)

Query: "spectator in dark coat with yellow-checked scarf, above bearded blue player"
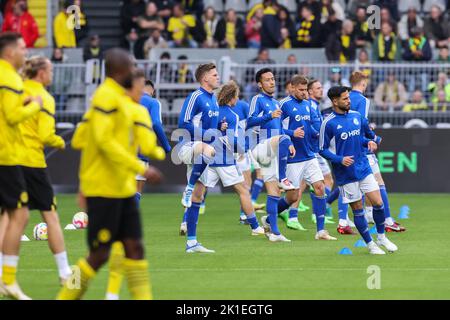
(296, 6, 321, 48)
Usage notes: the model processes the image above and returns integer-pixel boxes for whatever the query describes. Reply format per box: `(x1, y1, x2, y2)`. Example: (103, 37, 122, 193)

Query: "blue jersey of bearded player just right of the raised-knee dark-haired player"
(280, 96, 317, 163)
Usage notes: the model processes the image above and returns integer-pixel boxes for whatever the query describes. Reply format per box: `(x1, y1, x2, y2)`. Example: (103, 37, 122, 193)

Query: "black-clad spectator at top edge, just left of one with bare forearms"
(120, 0, 145, 47)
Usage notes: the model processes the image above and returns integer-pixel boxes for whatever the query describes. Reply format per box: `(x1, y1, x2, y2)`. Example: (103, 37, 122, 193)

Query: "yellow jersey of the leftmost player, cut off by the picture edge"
(0, 59, 41, 166)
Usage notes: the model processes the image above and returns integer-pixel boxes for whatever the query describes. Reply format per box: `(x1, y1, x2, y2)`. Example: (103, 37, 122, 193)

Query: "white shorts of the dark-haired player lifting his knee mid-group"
(252, 139, 278, 182)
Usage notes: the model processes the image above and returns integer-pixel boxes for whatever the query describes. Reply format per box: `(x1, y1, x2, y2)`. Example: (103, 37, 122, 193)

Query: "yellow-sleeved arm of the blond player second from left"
(38, 101, 66, 149)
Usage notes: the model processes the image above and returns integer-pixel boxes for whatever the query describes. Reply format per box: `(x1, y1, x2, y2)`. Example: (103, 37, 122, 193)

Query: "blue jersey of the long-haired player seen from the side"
(210, 105, 245, 167)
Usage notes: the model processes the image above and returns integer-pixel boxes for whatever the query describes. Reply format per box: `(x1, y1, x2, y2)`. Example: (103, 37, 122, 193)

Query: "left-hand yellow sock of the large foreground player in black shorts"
(56, 258, 95, 300)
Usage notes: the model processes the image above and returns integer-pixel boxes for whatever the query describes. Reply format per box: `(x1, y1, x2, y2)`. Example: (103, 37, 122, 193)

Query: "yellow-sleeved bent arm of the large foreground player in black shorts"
(90, 105, 145, 174)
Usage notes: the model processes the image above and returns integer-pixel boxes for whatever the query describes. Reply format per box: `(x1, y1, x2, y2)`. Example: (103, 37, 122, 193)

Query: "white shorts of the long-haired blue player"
(187, 165, 244, 188)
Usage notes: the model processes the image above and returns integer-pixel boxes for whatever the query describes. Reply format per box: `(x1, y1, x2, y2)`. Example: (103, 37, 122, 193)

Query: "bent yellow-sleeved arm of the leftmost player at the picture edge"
(1, 86, 41, 125)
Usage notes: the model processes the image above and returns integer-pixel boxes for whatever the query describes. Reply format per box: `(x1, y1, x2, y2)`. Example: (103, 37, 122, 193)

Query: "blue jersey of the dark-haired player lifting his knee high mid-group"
(247, 93, 284, 148)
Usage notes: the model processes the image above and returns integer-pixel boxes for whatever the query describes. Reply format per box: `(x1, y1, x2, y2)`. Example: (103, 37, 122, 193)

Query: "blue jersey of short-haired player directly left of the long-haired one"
(178, 87, 219, 143)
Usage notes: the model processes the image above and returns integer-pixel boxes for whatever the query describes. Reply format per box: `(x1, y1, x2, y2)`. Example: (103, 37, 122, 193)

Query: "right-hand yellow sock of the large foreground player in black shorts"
(123, 258, 153, 300)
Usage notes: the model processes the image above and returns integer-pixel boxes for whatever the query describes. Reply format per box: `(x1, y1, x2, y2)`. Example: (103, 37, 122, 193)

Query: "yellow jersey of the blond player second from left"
(19, 80, 65, 168)
